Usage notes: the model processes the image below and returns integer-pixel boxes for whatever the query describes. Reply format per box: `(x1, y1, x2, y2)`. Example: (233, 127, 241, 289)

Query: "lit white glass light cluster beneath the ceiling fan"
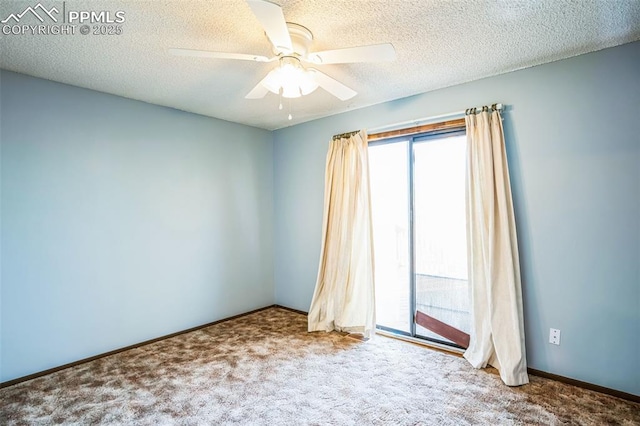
(262, 56, 318, 98)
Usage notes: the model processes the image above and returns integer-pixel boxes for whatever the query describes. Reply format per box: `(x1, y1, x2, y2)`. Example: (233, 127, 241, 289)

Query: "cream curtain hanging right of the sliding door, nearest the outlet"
(464, 107, 529, 386)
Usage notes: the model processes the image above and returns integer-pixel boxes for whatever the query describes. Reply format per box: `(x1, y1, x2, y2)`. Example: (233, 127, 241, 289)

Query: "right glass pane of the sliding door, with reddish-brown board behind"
(413, 135, 470, 342)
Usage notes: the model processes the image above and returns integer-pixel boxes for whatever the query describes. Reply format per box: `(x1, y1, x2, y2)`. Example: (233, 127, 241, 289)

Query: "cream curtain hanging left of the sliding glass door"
(308, 130, 375, 338)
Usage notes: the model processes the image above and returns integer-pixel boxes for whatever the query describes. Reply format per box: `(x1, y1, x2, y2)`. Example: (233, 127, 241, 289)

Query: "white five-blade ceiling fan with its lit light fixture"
(169, 0, 395, 102)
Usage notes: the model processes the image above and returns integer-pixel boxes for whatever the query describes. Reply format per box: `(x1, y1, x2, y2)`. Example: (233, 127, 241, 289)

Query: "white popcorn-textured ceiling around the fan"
(0, 0, 640, 130)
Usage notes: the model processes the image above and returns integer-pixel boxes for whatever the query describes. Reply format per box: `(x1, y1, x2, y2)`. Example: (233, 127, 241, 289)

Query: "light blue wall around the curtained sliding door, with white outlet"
(274, 42, 640, 395)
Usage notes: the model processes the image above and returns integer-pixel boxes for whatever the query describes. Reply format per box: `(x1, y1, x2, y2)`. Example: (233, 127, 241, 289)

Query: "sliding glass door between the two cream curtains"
(369, 130, 470, 347)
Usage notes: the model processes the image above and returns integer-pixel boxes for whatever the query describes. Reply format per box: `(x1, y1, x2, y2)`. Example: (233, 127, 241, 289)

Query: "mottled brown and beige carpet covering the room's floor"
(0, 308, 640, 425)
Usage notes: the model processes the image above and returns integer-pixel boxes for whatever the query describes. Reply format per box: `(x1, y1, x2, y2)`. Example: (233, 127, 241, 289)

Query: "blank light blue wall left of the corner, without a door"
(0, 71, 274, 381)
